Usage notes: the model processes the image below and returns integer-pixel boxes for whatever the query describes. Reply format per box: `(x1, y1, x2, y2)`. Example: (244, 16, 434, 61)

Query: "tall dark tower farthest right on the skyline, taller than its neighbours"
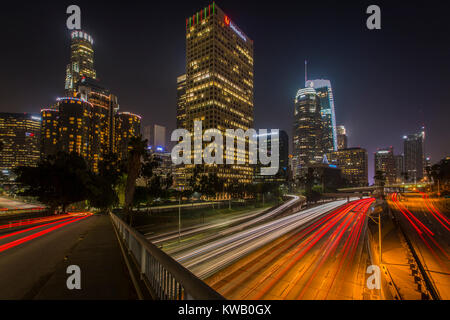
(403, 128, 425, 182)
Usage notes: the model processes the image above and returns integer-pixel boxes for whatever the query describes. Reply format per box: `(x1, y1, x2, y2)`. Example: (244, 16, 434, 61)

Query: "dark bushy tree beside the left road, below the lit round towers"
(14, 152, 92, 212)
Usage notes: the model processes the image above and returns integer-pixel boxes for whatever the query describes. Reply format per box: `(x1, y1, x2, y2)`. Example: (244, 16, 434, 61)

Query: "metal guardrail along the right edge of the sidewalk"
(110, 213, 225, 300)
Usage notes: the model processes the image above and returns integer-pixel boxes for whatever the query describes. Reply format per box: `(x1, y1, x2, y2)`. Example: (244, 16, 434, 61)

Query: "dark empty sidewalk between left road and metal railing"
(32, 215, 137, 300)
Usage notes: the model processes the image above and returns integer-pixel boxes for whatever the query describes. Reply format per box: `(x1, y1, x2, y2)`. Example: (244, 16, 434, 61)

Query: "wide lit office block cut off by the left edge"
(0, 113, 41, 174)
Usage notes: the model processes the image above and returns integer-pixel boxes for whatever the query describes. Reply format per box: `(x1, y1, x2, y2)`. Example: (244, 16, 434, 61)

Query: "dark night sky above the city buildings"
(0, 0, 450, 181)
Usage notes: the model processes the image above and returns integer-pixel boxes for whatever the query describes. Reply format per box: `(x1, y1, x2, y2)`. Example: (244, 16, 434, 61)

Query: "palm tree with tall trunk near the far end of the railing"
(124, 135, 147, 226)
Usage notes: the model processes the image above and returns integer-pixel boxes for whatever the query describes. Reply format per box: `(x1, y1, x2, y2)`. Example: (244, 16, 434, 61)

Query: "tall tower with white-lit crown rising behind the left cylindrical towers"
(64, 30, 97, 97)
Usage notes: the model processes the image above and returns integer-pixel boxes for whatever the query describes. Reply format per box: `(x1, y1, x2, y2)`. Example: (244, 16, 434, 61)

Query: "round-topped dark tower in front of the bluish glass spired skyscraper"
(292, 87, 325, 175)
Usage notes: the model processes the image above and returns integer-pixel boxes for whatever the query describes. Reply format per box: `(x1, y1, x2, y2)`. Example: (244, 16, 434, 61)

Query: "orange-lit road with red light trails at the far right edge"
(388, 193, 450, 300)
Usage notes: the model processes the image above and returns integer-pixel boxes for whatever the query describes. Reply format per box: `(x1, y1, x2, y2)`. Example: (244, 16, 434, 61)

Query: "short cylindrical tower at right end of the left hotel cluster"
(115, 112, 141, 160)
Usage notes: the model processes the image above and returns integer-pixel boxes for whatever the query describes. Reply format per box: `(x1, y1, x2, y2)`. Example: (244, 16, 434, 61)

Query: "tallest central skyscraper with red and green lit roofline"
(181, 3, 253, 184)
